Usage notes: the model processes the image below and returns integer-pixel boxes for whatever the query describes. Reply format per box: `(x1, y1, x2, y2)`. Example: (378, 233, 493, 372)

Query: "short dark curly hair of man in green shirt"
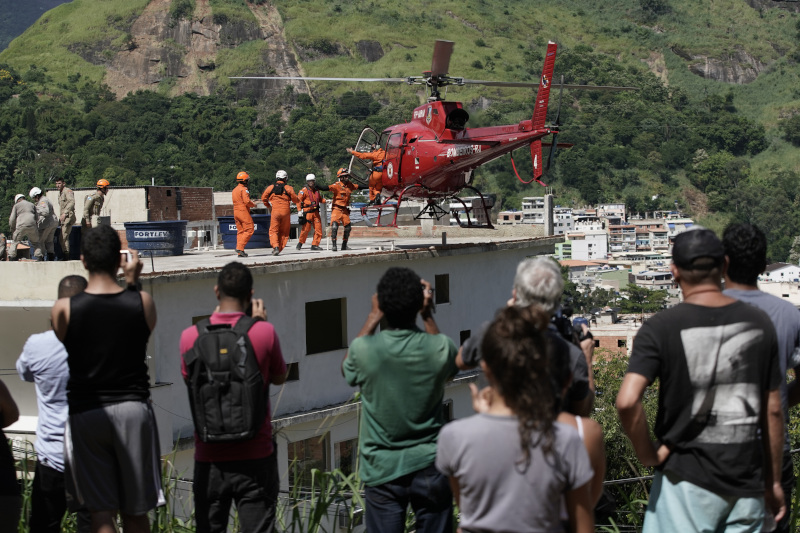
(378, 267, 424, 328)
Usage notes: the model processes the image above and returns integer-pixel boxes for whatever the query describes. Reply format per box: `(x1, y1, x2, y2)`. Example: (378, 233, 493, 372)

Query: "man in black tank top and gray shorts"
(51, 226, 164, 533)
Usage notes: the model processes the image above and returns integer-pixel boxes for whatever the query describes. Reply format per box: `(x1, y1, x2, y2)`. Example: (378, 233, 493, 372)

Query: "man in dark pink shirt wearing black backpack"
(180, 262, 287, 533)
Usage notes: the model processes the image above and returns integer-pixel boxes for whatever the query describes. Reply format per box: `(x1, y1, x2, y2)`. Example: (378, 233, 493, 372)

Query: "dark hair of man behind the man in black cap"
(722, 224, 767, 285)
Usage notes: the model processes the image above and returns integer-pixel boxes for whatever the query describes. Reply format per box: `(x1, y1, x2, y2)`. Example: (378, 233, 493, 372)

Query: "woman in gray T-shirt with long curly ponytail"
(436, 307, 594, 533)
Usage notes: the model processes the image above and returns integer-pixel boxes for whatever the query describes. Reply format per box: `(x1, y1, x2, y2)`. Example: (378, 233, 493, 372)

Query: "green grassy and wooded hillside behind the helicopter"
(0, 0, 800, 260)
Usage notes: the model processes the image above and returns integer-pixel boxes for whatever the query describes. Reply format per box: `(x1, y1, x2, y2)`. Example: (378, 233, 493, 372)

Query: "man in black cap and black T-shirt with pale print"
(617, 228, 786, 532)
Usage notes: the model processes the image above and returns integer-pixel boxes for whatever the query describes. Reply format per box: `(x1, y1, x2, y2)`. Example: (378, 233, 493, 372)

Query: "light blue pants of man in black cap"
(642, 472, 764, 533)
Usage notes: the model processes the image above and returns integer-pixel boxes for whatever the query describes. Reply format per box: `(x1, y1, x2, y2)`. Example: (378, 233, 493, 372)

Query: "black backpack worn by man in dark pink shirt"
(183, 316, 269, 442)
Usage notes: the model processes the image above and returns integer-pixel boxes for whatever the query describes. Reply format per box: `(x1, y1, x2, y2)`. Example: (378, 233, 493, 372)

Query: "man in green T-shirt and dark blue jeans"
(342, 267, 458, 533)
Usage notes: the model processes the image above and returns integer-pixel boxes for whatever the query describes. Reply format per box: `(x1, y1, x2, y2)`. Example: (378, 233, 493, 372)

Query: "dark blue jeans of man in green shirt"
(364, 465, 453, 533)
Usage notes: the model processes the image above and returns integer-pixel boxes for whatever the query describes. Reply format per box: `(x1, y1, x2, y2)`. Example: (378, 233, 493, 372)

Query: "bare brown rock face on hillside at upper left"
(98, 0, 306, 99)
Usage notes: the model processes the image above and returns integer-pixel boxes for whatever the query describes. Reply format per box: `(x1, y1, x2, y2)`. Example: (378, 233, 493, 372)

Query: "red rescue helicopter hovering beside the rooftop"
(232, 40, 636, 228)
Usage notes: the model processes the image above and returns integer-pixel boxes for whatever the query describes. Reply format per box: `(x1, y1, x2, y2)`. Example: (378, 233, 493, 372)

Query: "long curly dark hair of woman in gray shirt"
(481, 307, 557, 469)
